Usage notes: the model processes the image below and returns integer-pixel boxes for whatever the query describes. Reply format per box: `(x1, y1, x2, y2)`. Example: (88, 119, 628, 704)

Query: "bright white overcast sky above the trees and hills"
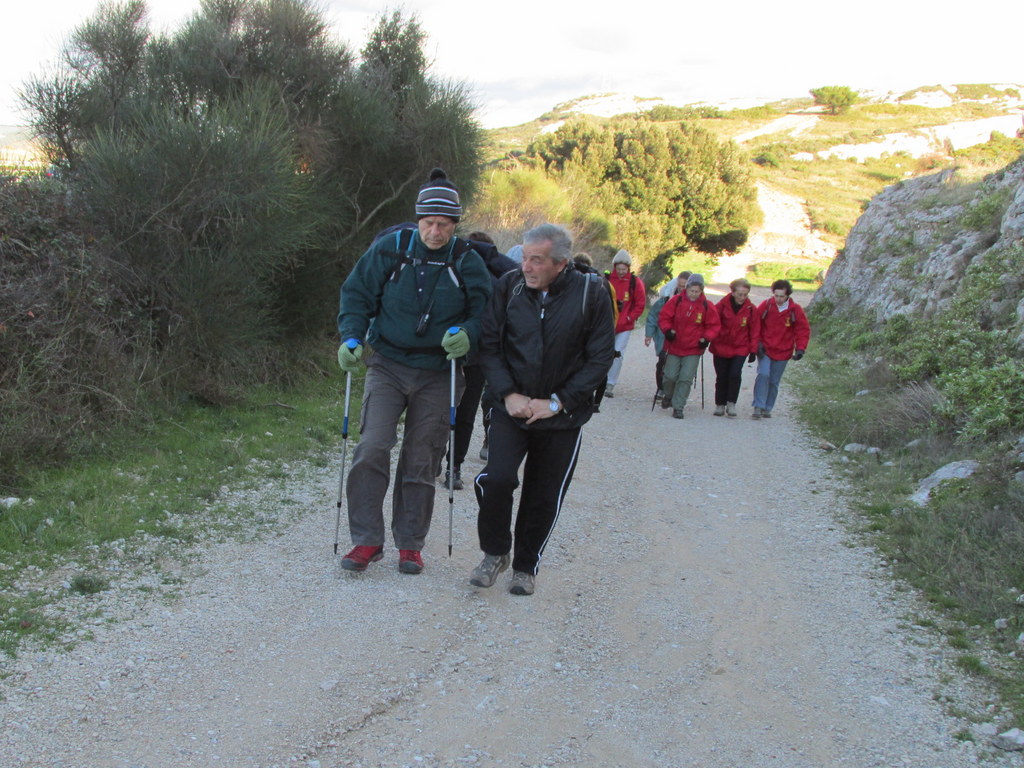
(0, 0, 1024, 128)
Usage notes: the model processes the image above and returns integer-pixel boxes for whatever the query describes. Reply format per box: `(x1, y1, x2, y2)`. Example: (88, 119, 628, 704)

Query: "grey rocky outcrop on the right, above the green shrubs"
(811, 159, 1024, 346)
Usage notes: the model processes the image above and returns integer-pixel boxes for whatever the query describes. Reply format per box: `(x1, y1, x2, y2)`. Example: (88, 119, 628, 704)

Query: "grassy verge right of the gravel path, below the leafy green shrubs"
(794, 339, 1024, 729)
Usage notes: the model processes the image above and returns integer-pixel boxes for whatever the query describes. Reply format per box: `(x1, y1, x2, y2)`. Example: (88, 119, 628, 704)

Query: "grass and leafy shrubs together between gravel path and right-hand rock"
(796, 244, 1024, 727)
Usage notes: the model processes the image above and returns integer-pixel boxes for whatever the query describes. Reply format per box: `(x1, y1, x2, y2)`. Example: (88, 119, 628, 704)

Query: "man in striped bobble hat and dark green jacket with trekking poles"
(338, 168, 492, 573)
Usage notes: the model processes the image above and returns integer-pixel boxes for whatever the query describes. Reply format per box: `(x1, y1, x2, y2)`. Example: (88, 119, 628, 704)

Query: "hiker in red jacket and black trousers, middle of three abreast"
(711, 278, 761, 417)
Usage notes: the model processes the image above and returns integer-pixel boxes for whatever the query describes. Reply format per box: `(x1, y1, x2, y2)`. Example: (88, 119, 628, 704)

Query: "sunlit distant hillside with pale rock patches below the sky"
(487, 84, 1024, 253)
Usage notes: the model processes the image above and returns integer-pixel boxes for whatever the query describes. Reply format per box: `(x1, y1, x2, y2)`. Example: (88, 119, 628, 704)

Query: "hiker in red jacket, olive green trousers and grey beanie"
(657, 274, 721, 419)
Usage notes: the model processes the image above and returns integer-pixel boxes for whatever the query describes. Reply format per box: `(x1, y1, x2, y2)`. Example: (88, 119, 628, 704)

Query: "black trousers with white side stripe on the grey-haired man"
(473, 409, 583, 575)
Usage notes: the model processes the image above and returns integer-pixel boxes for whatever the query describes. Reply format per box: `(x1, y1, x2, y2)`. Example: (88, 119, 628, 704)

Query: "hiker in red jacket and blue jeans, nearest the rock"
(754, 280, 811, 419)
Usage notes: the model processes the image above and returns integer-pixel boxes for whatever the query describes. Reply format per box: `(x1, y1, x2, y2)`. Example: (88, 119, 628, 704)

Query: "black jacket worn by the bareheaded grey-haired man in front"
(479, 261, 615, 429)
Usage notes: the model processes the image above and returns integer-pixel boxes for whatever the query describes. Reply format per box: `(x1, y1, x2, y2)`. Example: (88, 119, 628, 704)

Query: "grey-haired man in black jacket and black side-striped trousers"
(469, 224, 614, 595)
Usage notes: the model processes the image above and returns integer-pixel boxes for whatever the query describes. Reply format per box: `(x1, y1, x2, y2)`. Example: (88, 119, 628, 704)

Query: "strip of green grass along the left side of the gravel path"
(0, 356, 361, 654)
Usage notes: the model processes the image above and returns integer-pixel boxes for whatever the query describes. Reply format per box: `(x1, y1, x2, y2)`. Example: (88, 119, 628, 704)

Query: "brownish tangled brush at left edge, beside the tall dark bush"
(0, 179, 150, 483)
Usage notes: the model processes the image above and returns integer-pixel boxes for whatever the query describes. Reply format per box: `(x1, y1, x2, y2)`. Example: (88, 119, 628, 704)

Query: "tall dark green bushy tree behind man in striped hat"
(16, 0, 480, 387)
